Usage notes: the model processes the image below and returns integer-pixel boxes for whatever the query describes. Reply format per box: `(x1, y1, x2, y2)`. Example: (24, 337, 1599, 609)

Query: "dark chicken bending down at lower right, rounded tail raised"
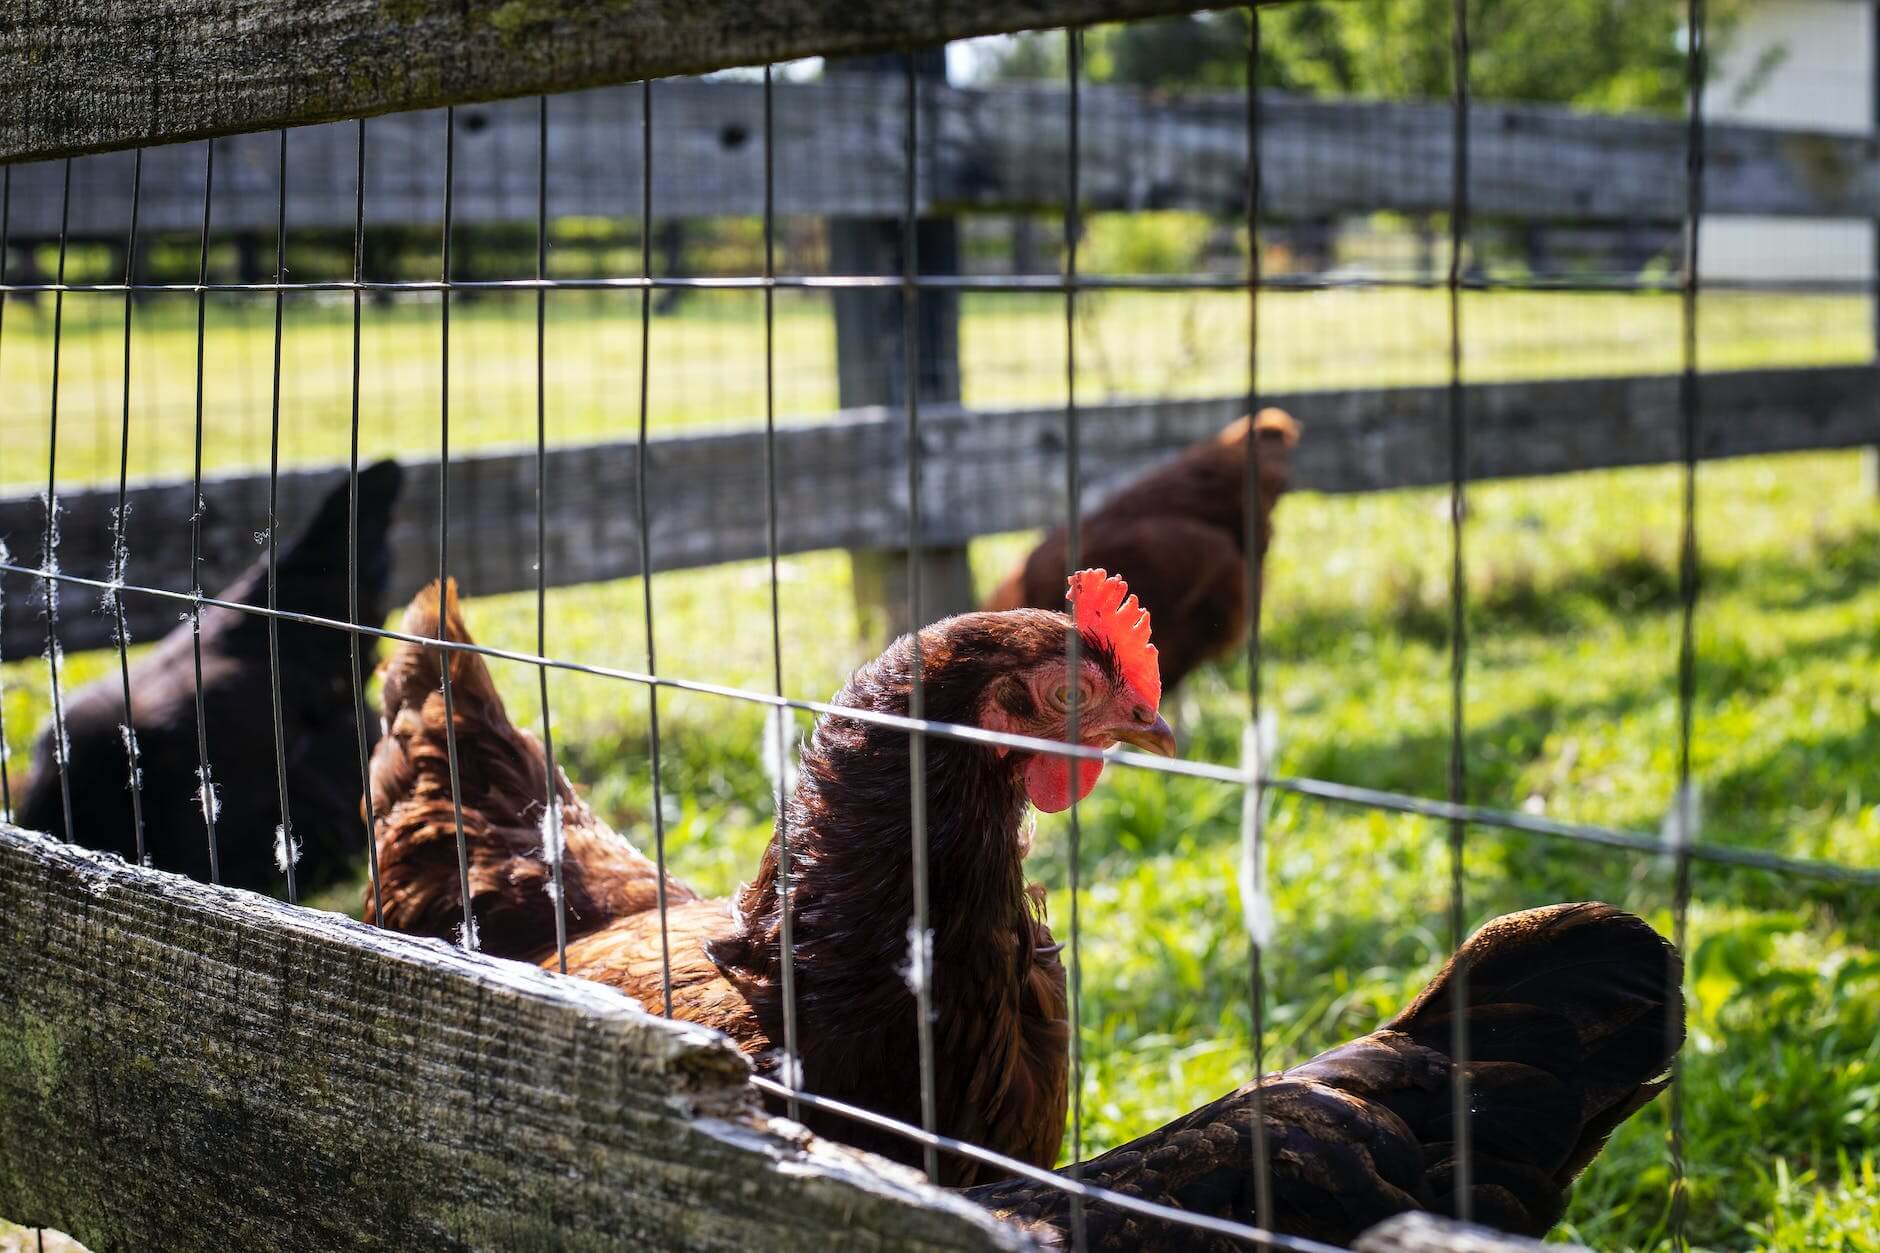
(968, 903, 1684, 1249)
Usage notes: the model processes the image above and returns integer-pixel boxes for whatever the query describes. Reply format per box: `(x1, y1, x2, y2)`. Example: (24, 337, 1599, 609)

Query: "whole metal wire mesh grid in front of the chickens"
(0, 0, 1880, 1253)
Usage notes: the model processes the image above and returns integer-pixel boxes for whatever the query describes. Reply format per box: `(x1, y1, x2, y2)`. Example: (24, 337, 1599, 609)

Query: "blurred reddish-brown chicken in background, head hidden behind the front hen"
(985, 408, 1299, 690)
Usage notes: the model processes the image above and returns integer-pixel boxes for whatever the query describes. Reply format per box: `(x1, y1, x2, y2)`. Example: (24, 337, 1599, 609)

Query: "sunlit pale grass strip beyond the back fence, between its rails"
(0, 290, 1872, 489)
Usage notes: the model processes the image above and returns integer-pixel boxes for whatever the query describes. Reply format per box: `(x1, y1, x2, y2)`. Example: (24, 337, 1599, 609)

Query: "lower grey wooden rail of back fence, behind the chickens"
(0, 367, 1880, 658)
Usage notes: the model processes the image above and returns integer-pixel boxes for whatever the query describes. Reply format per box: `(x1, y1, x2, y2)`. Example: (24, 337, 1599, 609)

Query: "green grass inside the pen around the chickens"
(4, 444, 1880, 1249)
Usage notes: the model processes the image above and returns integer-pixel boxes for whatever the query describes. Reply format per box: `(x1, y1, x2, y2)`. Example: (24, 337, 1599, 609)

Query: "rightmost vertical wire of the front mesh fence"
(1666, 0, 1709, 1251)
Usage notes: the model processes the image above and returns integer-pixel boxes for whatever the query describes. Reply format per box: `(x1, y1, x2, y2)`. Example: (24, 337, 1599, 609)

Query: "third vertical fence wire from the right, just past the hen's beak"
(1241, 4, 1273, 1229)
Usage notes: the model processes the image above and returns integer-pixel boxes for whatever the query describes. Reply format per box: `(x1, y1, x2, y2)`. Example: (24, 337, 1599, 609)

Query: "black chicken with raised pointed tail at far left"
(15, 461, 402, 892)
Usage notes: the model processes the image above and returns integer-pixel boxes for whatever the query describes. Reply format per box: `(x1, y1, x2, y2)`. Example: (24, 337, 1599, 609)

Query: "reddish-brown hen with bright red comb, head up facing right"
(367, 570, 1175, 1183)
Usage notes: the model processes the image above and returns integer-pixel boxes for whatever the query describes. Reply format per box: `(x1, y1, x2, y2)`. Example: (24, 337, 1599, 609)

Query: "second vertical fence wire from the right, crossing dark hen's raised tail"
(1448, 0, 1474, 1223)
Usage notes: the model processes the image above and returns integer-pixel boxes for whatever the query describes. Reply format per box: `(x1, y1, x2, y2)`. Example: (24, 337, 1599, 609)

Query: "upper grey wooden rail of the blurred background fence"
(0, 76, 1880, 239)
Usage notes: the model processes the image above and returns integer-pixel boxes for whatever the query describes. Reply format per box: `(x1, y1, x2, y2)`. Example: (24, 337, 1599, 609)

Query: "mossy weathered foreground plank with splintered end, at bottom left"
(0, 826, 1023, 1253)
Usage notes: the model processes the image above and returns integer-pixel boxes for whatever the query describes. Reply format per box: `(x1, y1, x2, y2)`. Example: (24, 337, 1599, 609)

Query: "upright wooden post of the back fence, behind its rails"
(823, 49, 974, 642)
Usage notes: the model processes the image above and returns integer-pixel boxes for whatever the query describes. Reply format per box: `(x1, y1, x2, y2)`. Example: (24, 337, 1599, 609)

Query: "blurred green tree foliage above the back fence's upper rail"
(993, 0, 1743, 113)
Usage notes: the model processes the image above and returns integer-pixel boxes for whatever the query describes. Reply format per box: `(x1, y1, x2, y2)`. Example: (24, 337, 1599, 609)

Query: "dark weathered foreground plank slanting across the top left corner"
(0, 0, 1233, 160)
